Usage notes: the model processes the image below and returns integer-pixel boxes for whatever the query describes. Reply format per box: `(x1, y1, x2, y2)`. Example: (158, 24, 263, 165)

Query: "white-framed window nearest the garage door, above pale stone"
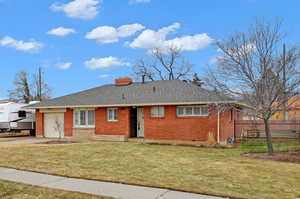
(74, 110, 95, 128)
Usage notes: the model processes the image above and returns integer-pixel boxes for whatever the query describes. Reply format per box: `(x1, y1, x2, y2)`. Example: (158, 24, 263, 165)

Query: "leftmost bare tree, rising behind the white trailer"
(8, 71, 32, 103)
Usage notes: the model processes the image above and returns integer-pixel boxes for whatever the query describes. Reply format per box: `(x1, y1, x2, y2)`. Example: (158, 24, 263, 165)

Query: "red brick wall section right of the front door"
(144, 106, 234, 141)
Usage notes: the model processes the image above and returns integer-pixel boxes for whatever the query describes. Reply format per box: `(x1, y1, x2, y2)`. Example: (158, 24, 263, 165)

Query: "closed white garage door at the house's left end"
(44, 113, 64, 138)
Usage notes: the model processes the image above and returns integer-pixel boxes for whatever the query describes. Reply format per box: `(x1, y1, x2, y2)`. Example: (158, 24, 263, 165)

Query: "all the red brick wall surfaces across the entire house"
(36, 106, 238, 141)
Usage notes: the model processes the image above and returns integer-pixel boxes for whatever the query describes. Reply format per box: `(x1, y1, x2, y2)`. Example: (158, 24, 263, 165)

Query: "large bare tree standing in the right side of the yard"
(206, 20, 300, 153)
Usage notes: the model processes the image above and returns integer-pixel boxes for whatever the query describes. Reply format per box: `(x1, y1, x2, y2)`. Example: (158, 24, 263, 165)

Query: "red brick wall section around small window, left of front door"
(95, 107, 130, 137)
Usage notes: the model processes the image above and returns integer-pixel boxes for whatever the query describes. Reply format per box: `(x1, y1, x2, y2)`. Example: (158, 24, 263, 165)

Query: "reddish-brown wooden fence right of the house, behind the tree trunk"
(234, 120, 300, 141)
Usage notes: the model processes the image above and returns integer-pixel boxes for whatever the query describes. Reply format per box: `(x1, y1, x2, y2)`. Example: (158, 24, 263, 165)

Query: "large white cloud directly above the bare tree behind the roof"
(128, 23, 213, 51)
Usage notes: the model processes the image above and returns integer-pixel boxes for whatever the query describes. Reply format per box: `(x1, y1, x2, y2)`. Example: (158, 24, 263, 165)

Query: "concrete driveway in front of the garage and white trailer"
(0, 136, 51, 147)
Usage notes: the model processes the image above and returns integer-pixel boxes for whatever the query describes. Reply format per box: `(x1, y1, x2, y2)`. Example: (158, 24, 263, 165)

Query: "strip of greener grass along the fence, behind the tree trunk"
(240, 142, 300, 153)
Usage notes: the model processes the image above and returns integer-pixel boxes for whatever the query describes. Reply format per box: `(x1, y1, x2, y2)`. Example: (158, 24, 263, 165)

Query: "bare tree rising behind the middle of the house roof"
(134, 47, 193, 81)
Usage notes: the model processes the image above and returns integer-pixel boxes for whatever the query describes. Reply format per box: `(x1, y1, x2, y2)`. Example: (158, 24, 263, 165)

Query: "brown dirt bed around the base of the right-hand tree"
(243, 151, 300, 164)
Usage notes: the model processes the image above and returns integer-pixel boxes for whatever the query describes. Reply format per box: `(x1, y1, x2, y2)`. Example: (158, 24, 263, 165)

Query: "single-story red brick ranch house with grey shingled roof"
(25, 77, 244, 142)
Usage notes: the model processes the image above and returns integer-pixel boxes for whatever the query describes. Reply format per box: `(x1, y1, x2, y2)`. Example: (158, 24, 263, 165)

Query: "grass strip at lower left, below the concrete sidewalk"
(0, 180, 108, 199)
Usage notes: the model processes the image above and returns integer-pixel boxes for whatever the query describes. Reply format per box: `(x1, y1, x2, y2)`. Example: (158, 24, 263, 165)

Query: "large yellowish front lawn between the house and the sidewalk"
(0, 142, 300, 199)
